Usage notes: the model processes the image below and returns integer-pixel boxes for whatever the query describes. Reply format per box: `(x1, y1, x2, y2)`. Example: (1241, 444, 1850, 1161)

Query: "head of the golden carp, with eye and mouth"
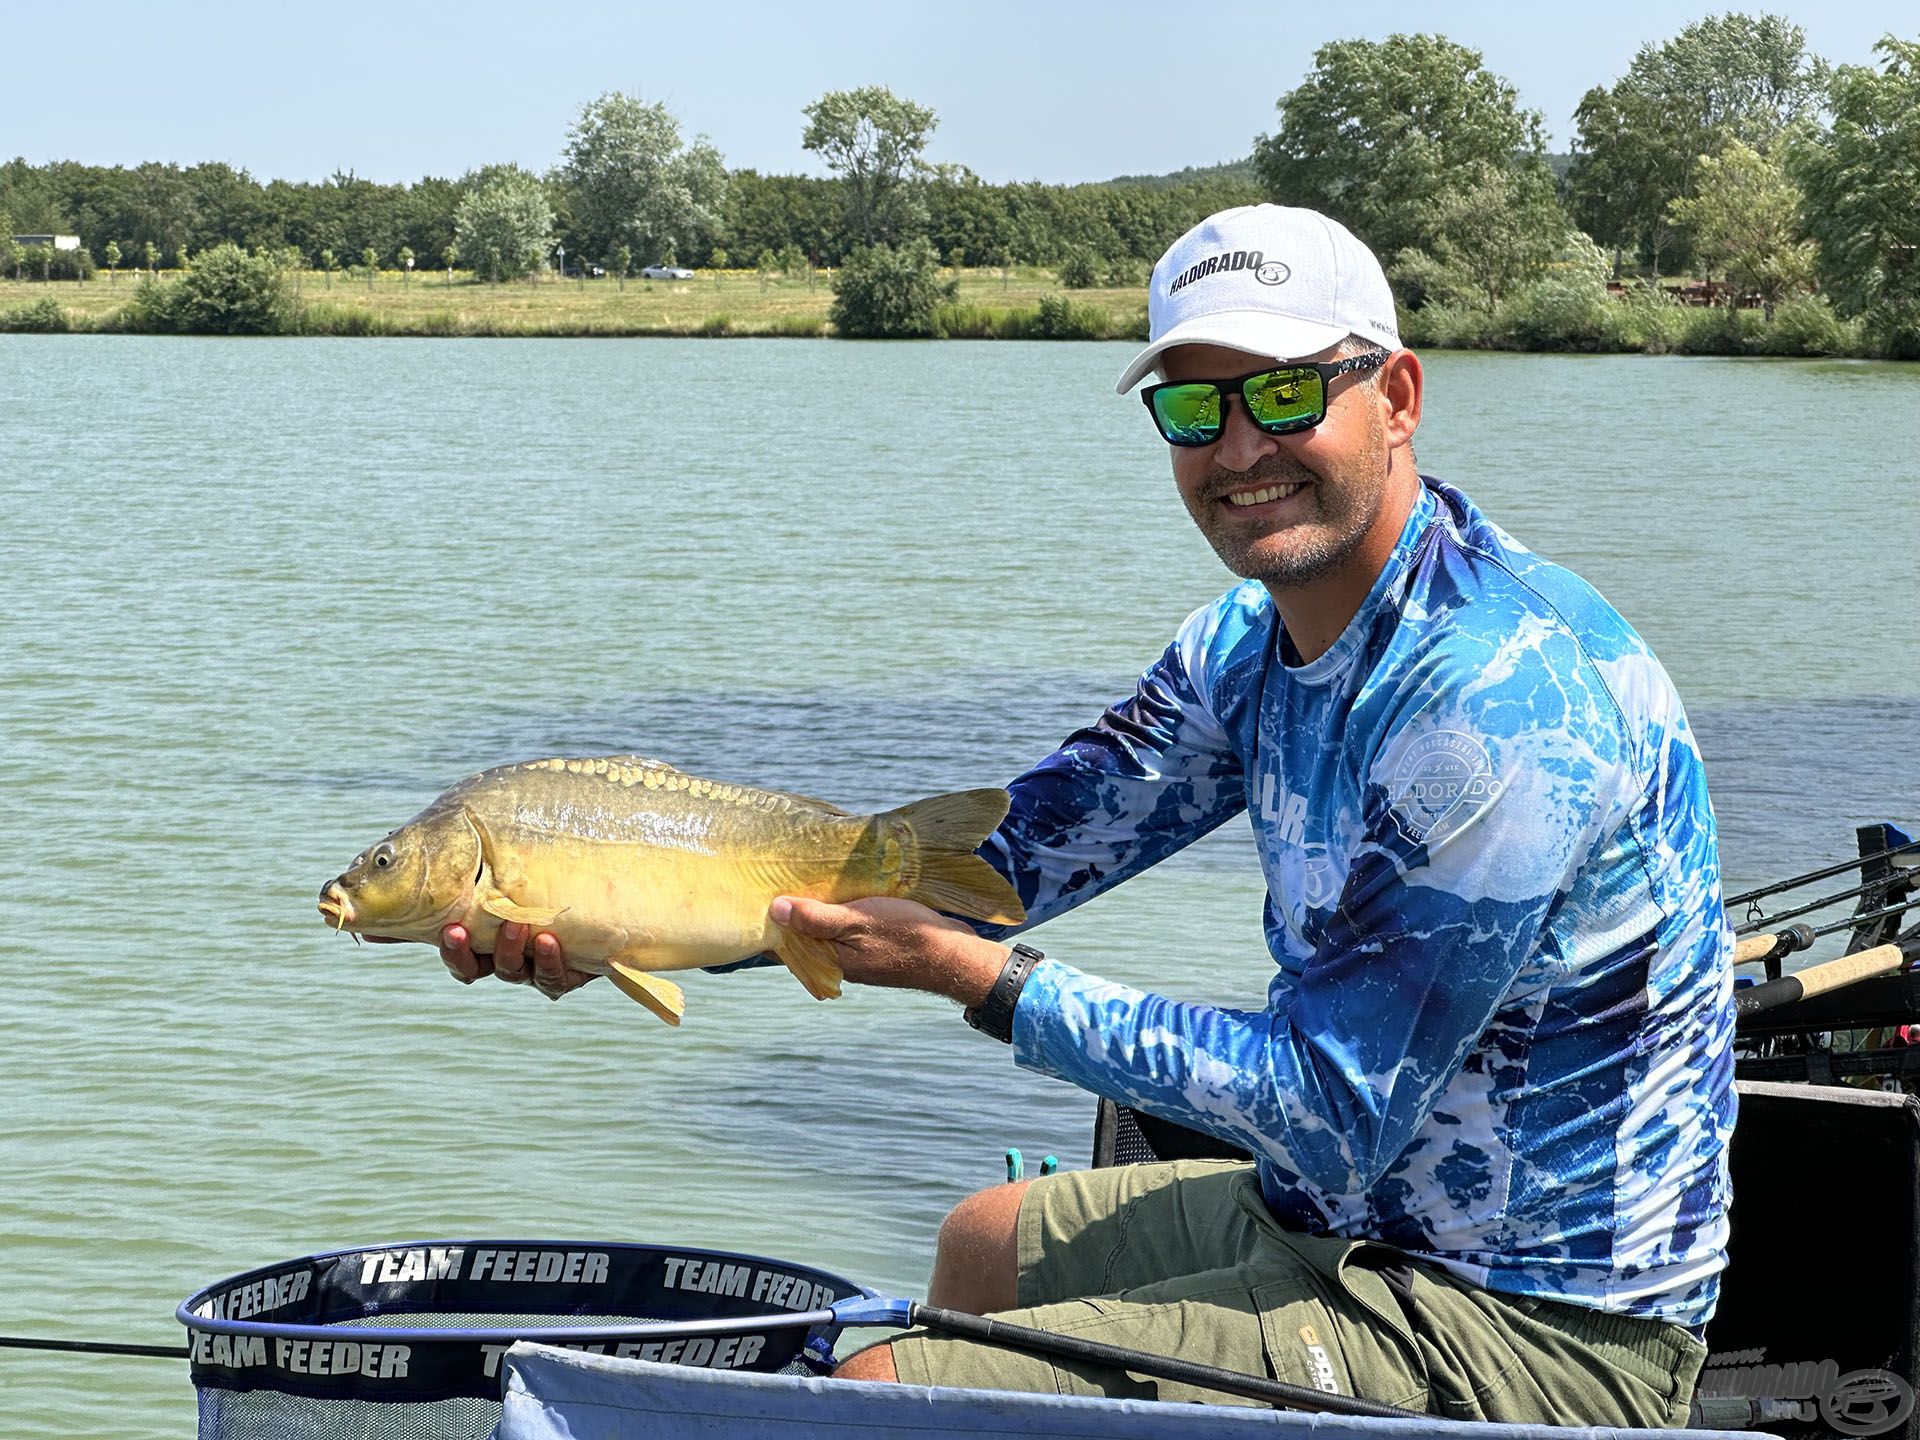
(319, 808, 482, 941)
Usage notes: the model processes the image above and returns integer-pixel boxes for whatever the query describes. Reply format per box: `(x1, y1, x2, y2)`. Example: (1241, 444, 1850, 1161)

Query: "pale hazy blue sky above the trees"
(0, 0, 1920, 182)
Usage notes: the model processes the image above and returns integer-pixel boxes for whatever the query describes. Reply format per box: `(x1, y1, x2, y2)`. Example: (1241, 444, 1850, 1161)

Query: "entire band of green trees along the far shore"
(0, 13, 1920, 355)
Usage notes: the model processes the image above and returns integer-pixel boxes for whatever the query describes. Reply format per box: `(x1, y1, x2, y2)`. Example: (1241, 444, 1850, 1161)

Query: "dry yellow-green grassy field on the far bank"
(0, 269, 1146, 336)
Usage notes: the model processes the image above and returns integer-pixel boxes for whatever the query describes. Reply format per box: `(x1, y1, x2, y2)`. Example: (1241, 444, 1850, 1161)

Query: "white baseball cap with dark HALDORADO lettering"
(1116, 205, 1400, 396)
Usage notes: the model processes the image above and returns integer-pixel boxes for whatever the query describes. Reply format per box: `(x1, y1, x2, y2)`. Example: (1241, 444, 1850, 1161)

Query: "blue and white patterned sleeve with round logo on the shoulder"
(1014, 632, 1634, 1198)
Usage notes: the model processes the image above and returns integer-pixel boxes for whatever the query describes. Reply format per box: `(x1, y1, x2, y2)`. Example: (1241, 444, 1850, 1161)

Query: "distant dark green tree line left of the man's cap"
(0, 103, 1258, 284)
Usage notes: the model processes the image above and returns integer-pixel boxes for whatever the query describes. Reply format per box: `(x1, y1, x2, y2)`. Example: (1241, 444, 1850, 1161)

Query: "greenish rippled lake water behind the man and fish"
(0, 336, 1920, 1440)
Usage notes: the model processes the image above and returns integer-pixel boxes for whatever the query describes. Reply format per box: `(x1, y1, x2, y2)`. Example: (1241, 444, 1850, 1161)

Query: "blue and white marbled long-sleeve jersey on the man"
(985, 480, 1734, 1325)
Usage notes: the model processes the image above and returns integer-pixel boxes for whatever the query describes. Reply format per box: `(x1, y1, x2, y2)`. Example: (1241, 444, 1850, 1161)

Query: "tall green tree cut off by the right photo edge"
(1793, 35, 1920, 357)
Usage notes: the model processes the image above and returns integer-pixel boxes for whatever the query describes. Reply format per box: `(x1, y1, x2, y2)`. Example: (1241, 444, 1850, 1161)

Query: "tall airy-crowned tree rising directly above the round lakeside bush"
(801, 84, 939, 246)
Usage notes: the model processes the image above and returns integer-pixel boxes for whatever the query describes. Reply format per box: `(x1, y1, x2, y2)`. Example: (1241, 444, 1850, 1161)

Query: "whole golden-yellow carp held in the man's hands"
(321, 755, 1025, 1025)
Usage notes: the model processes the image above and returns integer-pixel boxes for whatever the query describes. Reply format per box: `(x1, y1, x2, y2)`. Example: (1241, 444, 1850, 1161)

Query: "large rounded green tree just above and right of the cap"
(1254, 35, 1546, 255)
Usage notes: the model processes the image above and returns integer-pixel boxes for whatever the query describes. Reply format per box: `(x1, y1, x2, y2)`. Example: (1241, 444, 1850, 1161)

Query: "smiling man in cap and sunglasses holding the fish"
(442, 205, 1734, 1427)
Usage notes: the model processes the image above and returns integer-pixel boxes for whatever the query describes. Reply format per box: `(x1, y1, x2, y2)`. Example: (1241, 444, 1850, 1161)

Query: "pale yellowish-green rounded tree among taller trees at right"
(1667, 140, 1814, 321)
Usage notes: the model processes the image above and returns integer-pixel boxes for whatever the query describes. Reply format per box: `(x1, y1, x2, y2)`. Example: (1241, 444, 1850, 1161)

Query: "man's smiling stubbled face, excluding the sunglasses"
(1162, 346, 1388, 589)
